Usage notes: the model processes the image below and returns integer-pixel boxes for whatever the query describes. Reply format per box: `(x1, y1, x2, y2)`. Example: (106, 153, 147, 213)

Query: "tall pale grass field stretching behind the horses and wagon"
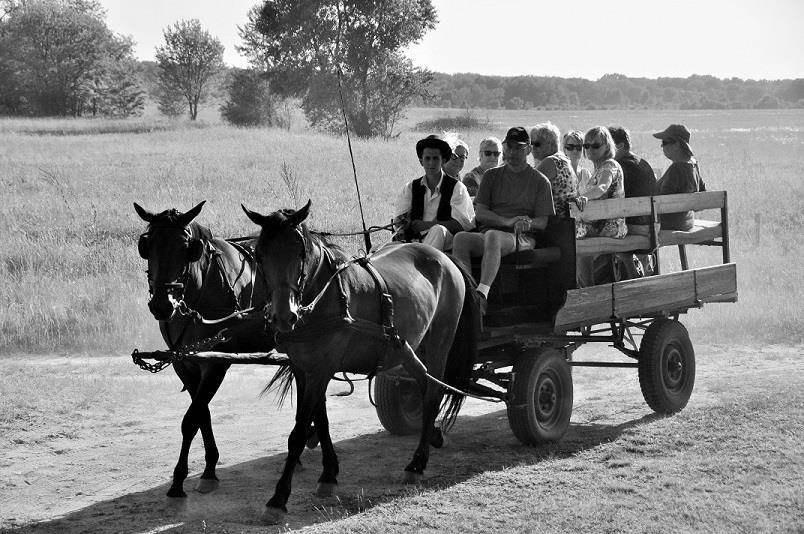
(0, 109, 804, 354)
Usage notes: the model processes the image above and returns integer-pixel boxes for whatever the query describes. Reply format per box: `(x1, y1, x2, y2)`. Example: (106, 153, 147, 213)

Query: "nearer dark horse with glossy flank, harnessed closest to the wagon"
(243, 202, 480, 522)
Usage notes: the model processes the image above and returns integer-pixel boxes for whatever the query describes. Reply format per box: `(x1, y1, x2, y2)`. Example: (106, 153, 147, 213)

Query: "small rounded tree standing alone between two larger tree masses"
(156, 19, 224, 120)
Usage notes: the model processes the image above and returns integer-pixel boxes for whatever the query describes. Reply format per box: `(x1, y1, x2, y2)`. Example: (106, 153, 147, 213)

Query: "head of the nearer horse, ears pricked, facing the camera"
(241, 201, 313, 332)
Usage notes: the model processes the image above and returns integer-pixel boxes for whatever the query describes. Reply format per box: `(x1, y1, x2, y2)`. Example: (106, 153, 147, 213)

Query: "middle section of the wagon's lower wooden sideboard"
(613, 271, 696, 317)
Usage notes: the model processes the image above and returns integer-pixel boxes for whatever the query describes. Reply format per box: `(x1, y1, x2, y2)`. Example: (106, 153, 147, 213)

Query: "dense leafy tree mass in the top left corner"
(0, 0, 143, 116)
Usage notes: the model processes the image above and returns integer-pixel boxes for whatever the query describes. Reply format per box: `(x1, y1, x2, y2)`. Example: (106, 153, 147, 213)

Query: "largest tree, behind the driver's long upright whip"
(238, 0, 436, 138)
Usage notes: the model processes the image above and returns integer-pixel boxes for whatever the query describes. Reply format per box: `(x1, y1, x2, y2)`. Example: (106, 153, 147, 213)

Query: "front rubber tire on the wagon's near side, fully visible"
(508, 349, 573, 445)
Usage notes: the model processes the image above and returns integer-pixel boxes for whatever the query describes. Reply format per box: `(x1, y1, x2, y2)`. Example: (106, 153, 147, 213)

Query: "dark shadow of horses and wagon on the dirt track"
(7, 410, 657, 534)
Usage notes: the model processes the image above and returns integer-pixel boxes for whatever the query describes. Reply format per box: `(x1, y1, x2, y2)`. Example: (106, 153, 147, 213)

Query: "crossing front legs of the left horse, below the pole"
(167, 368, 226, 497)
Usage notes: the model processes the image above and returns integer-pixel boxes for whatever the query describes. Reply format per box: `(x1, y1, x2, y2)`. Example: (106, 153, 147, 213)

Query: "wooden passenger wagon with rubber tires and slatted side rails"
(374, 191, 737, 445)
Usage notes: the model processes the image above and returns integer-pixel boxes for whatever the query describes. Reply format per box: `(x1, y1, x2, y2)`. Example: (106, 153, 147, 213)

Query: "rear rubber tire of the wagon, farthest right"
(639, 318, 695, 415)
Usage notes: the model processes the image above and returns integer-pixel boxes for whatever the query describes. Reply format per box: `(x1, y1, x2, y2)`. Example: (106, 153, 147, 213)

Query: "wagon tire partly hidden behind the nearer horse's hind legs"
(374, 375, 422, 436)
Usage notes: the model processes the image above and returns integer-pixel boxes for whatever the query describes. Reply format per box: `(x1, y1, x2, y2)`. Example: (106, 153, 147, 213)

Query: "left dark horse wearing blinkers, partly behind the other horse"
(134, 202, 327, 498)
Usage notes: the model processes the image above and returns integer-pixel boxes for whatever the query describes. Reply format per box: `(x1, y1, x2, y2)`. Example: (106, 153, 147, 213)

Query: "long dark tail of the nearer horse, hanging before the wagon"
(440, 254, 481, 431)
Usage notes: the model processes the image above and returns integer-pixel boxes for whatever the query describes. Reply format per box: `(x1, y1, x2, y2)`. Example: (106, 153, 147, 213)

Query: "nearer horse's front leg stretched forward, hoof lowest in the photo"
(262, 378, 329, 525)
